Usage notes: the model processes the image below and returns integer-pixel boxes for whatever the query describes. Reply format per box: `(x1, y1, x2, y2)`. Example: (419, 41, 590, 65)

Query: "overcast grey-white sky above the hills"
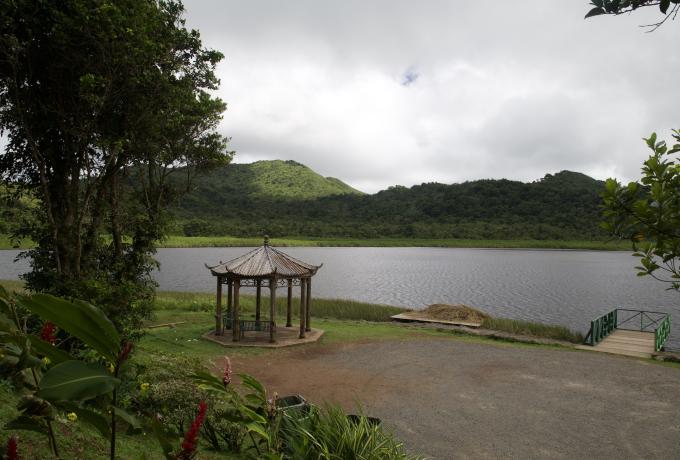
(185, 0, 680, 192)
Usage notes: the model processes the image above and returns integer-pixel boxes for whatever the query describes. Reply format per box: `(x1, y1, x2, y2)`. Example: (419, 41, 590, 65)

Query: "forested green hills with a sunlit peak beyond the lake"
(175, 161, 604, 239)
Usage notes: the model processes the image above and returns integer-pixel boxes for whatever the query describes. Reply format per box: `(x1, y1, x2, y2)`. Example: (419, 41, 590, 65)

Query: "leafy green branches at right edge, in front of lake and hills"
(603, 130, 680, 290)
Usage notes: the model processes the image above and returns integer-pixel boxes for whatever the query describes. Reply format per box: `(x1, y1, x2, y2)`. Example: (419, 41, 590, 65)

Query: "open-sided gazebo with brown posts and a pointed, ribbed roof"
(206, 236, 323, 343)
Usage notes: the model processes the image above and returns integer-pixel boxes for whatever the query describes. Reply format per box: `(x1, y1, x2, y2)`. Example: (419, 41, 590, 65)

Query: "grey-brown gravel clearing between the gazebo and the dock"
(236, 338, 680, 459)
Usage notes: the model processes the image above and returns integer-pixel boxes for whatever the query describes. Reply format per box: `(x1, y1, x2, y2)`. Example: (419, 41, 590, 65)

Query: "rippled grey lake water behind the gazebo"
(0, 248, 680, 346)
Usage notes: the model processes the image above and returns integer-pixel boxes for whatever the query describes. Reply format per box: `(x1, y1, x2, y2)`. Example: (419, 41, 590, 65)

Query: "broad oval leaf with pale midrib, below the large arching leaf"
(37, 360, 120, 401)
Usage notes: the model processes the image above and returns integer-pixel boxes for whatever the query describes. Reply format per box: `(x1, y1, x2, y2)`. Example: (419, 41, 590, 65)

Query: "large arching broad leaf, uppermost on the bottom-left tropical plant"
(18, 294, 120, 362)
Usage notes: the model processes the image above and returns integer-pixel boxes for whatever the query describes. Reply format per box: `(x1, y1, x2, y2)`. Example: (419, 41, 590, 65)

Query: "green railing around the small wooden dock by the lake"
(584, 308, 671, 351)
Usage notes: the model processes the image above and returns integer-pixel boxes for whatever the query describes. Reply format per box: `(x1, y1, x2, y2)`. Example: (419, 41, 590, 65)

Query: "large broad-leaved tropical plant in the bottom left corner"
(0, 287, 139, 459)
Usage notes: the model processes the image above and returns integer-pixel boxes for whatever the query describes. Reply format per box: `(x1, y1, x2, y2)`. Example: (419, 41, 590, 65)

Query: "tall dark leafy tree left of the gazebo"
(0, 0, 231, 331)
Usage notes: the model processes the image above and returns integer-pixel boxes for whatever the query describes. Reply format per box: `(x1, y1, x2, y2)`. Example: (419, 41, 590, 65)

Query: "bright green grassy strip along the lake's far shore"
(0, 235, 630, 251)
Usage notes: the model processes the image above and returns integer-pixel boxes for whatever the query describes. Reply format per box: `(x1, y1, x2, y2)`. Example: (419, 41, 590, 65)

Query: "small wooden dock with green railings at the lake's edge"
(577, 308, 671, 358)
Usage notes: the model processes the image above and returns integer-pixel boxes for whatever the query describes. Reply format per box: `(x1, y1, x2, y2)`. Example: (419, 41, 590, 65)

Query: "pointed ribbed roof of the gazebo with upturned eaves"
(206, 237, 321, 278)
